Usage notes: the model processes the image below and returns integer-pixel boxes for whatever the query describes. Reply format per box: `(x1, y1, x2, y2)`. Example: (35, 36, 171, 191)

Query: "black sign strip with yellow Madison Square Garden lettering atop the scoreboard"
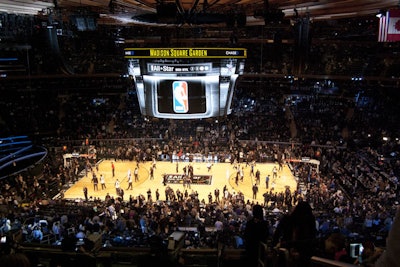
(125, 48, 247, 58)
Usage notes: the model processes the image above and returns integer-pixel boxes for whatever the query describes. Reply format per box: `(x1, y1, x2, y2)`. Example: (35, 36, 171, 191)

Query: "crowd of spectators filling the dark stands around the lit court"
(0, 10, 400, 267)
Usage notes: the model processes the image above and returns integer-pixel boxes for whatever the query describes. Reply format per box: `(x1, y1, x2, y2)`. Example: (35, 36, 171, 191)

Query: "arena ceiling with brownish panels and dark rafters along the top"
(0, 0, 399, 26)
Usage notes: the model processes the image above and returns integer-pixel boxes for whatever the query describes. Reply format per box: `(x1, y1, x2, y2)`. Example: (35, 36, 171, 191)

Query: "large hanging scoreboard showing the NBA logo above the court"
(125, 48, 247, 119)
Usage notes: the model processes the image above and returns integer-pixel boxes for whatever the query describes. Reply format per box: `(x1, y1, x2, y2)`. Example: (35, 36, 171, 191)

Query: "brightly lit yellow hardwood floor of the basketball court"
(64, 160, 297, 203)
